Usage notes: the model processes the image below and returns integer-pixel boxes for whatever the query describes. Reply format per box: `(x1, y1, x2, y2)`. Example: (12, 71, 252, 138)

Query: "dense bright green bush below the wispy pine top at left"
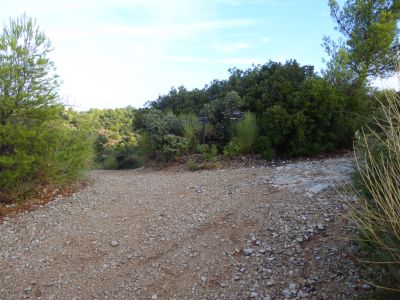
(0, 120, 92, 200)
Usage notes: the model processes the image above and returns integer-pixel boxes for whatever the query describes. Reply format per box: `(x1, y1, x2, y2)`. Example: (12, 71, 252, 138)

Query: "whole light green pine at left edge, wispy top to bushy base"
(0, 15, 92, 200)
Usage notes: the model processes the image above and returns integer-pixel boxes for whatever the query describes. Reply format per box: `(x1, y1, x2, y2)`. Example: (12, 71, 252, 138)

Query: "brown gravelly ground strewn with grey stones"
(0, 156, 370, 299)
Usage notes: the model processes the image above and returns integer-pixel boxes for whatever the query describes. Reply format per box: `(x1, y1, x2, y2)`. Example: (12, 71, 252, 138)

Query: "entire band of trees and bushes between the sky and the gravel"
(0, 0, 399, 202)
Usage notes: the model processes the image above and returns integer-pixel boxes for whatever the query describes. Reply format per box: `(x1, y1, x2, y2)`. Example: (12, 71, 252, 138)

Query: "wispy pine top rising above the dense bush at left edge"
(0, 15, 59, 126)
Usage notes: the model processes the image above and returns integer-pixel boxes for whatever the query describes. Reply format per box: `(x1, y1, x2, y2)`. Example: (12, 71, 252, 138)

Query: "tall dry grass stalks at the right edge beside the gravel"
(351, 96, 400, 292)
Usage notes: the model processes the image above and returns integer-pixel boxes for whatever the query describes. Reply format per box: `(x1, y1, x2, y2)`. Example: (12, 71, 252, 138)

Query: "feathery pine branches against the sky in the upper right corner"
(324, 0, 400, 87)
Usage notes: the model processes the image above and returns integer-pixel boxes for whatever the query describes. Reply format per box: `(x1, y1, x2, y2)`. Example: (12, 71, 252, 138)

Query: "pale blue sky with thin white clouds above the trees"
(0, 0, 394, 110)
